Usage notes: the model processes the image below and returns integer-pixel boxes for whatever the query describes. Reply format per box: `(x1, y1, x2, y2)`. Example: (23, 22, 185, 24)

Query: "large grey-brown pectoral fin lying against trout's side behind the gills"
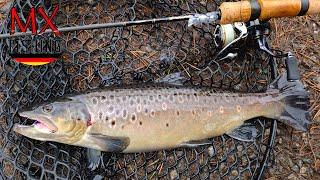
(87, 133, 130, 152)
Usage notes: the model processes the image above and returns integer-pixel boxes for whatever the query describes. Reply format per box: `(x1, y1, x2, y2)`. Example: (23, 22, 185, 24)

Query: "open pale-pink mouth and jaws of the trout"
(14, 111, 58, 133)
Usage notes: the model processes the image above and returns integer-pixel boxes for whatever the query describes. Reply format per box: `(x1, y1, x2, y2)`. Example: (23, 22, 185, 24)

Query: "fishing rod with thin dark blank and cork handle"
(0, 0, 320, 39)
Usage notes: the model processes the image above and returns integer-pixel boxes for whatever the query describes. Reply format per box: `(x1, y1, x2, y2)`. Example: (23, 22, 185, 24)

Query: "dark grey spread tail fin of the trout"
(269, 72, 311, 131)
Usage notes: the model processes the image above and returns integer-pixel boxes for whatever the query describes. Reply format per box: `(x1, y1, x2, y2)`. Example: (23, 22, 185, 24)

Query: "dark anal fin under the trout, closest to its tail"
(227, 123, 258, 142)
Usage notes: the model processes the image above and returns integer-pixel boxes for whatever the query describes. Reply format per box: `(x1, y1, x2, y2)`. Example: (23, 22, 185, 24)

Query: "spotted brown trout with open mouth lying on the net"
(14, 73, 310, 153)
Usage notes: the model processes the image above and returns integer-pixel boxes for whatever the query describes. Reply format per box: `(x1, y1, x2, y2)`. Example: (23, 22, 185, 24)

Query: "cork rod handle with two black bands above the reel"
(220, 0, 320, 24)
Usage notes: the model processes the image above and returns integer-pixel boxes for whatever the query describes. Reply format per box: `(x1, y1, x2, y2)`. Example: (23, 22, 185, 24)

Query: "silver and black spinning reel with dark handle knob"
(213, 20, 300, 81)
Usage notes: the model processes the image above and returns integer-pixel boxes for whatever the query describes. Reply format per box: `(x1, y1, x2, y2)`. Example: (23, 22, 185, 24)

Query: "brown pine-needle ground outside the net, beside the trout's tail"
(266, 15, 320, 179)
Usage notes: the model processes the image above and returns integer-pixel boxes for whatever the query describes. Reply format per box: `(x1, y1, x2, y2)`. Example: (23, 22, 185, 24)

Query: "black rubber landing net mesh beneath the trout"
(0, 0, 273, 179)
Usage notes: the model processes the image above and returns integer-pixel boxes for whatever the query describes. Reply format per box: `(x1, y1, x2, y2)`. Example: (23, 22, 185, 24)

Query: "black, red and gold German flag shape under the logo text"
(11, 54, 61, 66)
